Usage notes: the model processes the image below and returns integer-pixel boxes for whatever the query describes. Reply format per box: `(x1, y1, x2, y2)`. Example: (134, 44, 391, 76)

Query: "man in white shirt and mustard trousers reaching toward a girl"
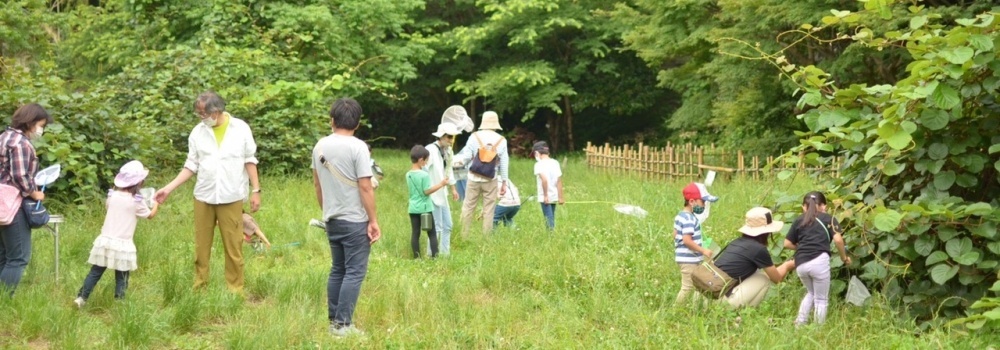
(154, 91, 260, 294)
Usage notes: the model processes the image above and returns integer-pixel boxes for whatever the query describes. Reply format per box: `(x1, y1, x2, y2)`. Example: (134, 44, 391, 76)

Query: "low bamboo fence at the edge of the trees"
(586, 142, 843, 180)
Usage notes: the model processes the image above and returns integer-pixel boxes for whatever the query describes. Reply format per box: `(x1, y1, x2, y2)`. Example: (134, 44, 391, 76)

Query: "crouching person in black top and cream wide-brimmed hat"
(715, 207, 795, 308)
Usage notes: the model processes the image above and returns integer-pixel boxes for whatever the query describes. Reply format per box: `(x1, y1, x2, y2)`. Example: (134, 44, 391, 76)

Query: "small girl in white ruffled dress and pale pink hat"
(73, 160, 158, 307)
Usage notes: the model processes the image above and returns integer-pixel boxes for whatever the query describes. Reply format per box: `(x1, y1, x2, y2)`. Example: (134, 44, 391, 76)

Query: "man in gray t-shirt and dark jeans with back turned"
(312, 98, 382, 337)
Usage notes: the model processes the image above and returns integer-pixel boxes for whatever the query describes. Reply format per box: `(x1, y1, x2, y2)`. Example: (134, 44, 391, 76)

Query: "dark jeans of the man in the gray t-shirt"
(326, 219, 371, 326)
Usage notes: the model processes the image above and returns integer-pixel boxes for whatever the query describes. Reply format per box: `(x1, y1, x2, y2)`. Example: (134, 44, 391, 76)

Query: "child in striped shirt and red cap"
(674, 182, 719, 305)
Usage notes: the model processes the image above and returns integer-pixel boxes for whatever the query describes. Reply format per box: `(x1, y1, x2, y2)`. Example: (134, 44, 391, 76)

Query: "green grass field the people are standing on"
(0, 150, 1000, 349)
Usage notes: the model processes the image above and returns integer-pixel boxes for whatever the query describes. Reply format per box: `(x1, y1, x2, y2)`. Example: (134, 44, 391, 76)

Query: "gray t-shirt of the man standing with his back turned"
(312, 134, 372, 222)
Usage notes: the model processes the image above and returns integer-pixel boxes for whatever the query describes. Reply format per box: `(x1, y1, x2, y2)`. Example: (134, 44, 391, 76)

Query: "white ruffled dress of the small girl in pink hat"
(87, 191, 150, 271)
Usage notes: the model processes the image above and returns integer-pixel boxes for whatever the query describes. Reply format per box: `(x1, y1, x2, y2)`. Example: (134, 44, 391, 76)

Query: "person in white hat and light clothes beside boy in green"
(424, 123, 460, 255)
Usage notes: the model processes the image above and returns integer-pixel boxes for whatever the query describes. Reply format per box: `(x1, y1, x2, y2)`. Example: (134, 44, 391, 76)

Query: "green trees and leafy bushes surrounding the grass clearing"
(0, 0, 1000, 334)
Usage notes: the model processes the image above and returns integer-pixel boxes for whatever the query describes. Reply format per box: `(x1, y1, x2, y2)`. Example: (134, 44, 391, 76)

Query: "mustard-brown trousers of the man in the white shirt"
(194, 200, 243, 293)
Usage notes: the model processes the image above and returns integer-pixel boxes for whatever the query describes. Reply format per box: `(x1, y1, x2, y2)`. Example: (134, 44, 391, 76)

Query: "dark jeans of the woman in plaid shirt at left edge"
(0, 210, 31, 296)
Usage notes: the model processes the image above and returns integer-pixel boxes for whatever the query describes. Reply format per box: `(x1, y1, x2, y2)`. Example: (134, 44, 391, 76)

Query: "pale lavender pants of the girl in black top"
(795, 253, 830, 325)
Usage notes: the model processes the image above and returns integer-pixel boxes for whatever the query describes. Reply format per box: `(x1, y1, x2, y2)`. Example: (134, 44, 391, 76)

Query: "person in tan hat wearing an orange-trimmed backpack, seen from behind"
(455, 111, 509, 238)
